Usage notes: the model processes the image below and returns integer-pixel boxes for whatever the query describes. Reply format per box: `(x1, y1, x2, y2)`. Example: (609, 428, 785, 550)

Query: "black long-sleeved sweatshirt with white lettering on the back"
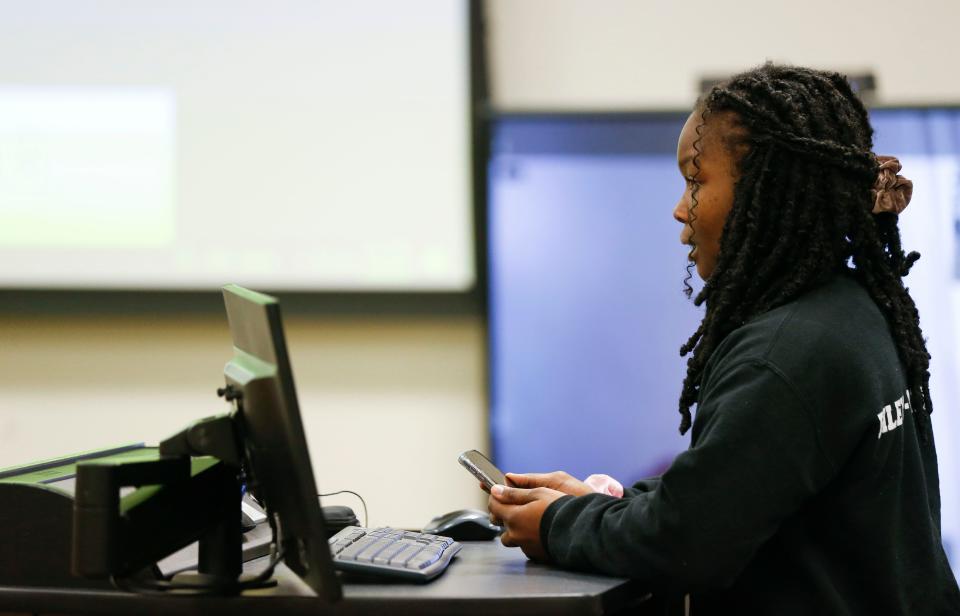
(540, 274, 960, 616)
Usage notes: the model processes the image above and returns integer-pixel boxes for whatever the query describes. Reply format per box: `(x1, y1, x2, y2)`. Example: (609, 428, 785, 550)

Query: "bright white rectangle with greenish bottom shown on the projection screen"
(0, 86, 176, 248)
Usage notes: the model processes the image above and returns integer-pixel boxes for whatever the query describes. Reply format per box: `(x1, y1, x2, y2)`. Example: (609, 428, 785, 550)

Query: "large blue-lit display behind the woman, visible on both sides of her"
(488, 109, 960, 568)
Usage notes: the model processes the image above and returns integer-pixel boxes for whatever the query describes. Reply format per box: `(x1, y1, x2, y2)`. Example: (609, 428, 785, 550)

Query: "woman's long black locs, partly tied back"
(680, 64, 933, 439)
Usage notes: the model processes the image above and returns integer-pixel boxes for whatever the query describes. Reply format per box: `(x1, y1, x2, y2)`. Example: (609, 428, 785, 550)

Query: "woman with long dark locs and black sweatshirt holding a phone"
(489, 65, 960, 616)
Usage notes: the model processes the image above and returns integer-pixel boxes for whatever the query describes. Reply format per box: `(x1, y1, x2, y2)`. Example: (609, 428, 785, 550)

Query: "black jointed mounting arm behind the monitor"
(71, 402, 249, 588)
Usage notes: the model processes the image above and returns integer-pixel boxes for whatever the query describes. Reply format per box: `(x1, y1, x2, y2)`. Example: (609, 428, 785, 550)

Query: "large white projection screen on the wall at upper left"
(0, 0, 475, 292)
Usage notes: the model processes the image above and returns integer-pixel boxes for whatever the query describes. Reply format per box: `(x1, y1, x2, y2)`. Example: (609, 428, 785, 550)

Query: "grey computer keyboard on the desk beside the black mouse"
(330, 526, 462, 582)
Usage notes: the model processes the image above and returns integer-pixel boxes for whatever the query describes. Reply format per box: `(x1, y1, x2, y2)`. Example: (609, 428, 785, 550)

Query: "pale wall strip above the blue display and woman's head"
(487, 0, 960, 109)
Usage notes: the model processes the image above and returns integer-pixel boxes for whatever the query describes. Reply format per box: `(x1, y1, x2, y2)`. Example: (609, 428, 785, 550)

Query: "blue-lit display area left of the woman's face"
(489, 114, 699, 483)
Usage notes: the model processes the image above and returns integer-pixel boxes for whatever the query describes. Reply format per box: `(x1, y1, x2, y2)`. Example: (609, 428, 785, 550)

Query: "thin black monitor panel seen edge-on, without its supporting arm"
(223, 285, 341, 601)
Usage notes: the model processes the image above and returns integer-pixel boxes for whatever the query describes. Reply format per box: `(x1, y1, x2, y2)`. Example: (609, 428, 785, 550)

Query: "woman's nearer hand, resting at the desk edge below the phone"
(487, 486, 564, 562)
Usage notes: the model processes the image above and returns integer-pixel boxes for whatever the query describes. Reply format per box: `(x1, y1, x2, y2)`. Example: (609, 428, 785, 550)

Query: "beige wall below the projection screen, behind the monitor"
(0, 316, 487, 527)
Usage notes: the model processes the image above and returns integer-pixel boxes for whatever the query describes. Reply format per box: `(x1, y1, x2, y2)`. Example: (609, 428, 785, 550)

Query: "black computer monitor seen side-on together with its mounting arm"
(71, 285, 341, 601)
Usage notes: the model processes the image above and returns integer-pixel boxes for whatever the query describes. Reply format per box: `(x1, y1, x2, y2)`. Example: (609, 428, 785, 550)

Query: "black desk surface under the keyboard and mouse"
(0, 541, 653, 616)
